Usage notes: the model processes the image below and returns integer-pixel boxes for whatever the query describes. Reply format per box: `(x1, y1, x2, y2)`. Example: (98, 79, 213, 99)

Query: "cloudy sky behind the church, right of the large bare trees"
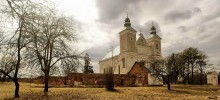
(53, 0, 220, 72)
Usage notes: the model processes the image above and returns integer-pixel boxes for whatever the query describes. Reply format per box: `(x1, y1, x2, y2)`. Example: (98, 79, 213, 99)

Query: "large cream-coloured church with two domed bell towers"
(99, 17, 162, 74)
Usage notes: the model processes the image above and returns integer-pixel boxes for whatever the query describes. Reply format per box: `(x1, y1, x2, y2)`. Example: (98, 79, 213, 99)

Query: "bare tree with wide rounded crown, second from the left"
(24, 9, 77, 92)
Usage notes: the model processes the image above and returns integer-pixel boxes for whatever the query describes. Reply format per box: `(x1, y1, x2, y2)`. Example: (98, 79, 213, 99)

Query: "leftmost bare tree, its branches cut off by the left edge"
(0, 0, 49, 97)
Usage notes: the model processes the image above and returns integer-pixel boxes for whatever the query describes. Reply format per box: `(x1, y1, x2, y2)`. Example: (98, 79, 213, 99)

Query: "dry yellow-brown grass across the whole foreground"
(0, 83, 220, 100)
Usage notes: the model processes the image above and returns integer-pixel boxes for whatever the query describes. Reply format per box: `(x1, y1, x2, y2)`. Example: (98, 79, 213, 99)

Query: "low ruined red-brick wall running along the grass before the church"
(33, 73, 137, 87)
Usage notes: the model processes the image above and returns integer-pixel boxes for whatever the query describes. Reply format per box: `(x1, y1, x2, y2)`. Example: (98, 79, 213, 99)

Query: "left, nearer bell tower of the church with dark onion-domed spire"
(119, 16, 137, 53)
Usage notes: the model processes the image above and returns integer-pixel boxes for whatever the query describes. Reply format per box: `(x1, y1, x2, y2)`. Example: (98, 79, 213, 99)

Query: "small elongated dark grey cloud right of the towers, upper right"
(164, 7, 201, 22)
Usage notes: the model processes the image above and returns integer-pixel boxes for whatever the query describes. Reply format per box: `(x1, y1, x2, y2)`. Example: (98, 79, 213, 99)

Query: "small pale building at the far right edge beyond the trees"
(207, 71, 218, 85)
